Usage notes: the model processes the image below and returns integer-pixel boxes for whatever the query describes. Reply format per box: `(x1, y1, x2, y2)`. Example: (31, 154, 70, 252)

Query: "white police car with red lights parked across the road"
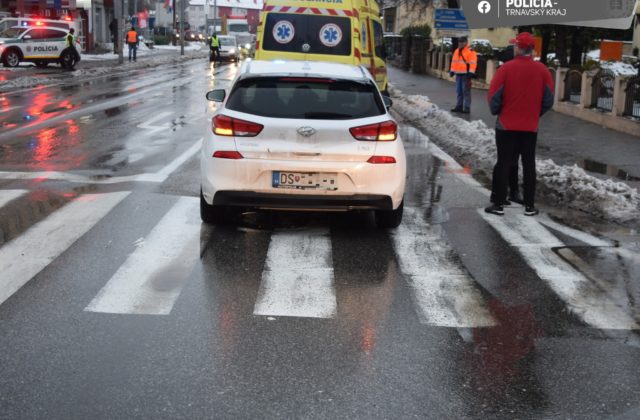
(0, 26, 80, 67)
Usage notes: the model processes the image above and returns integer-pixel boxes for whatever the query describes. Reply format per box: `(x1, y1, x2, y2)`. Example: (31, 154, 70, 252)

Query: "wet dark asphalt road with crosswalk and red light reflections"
(0, 61, 640, 419)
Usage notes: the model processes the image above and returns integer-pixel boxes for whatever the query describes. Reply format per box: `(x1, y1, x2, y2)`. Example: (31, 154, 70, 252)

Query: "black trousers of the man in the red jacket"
(492, 130, 538, 207)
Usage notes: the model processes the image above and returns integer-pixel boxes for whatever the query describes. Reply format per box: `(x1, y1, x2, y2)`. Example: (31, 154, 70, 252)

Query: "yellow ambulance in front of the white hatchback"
(255, 0, 387, 92)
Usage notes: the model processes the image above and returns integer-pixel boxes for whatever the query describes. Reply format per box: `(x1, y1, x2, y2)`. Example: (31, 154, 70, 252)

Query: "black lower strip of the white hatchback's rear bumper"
(213, 191, 393, 211)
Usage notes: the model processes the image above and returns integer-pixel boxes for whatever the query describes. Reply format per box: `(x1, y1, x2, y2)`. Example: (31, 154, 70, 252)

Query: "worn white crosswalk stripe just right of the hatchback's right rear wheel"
(392, 207, 497, 328)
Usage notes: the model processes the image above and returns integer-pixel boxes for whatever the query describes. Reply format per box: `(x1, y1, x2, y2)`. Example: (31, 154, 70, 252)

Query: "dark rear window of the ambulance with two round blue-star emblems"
(263, 13, 351, 55)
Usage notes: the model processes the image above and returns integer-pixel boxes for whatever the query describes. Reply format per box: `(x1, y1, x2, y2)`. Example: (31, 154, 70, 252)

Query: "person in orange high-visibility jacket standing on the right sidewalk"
(449, 37, 478, 114)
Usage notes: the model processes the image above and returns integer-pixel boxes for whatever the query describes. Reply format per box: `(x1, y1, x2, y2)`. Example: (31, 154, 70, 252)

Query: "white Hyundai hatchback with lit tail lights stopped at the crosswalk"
(200, 60, 406, 227)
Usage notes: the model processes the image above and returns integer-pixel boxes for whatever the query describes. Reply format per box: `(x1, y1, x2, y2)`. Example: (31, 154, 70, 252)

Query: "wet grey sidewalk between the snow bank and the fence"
(388, 66, 640, 189)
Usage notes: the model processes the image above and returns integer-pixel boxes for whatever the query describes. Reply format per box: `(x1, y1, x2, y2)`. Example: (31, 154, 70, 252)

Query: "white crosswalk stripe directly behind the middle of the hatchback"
(253, 229, 337, 318)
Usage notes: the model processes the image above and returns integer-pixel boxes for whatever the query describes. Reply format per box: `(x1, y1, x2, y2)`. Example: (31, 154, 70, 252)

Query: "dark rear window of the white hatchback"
(226, 77, 386, 120)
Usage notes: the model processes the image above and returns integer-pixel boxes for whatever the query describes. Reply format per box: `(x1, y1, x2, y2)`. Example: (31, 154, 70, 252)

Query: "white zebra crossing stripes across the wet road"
(0, 190, 640, 330)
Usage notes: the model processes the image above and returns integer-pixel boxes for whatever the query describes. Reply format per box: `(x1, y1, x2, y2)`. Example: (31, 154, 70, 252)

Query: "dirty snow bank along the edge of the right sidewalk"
(389, 86, 640, 223)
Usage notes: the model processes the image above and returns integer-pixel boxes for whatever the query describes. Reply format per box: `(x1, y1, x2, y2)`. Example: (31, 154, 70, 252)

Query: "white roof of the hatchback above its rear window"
(241, 60, 371, 81)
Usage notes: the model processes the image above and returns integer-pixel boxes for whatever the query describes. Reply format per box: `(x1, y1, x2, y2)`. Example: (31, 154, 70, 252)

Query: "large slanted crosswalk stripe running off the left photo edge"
(0, 192, 129, 304)
